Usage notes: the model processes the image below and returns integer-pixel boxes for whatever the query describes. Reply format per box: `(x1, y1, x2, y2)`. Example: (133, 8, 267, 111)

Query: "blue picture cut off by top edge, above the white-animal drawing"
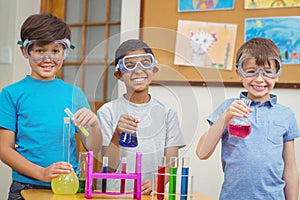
(178, 0, 234, 12)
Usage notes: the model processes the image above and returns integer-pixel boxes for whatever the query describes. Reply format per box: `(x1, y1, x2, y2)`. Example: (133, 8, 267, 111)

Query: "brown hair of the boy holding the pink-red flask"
(236, 37, 281, 68)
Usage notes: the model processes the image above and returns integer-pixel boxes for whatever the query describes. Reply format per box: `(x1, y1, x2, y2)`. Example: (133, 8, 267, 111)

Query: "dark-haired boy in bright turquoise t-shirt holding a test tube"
(0, 14, 102, 200)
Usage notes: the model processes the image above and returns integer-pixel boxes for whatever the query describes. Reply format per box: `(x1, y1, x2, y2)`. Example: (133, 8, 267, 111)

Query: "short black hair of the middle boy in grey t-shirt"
(115, 39, 154, 65)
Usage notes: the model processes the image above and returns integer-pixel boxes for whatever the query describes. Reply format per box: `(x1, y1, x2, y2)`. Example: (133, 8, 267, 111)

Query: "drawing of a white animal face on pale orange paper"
(174, 20, 237, 70)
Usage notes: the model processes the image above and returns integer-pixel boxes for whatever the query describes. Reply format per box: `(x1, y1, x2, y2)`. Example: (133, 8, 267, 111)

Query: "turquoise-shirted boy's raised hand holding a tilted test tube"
(72, 108, 98, 127)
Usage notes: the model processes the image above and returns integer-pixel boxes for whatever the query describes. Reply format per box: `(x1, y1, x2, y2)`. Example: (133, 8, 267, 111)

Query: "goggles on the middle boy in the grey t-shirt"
(116, 53, 157, 72)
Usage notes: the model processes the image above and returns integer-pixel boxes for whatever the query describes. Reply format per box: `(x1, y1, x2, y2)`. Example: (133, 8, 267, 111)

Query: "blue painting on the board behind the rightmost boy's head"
(245, 16, 300, 64)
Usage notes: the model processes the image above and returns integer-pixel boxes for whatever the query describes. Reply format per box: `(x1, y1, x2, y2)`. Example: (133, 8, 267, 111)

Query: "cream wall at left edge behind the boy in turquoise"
(0, 0, 40, 200)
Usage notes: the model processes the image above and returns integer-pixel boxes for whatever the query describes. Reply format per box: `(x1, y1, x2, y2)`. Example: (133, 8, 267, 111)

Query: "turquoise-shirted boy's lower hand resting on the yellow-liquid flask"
(41, 162, 73, 182)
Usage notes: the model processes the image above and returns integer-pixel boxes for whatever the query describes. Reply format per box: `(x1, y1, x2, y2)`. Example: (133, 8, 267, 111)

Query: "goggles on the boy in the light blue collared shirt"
(237, 56, 282, 78)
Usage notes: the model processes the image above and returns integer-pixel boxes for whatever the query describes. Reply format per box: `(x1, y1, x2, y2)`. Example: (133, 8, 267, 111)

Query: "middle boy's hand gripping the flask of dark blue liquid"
(116, 114, 140, 134)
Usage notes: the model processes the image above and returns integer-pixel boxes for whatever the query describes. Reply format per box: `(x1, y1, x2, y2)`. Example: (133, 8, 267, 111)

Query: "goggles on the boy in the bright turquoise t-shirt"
(23, 38, 73, 62)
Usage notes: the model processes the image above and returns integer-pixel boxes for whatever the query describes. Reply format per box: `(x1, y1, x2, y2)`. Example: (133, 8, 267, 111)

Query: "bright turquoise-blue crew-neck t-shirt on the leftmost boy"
(0, 75, 90, 186)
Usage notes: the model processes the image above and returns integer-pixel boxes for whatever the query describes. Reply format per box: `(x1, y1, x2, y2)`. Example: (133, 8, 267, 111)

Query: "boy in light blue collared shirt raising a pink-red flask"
(196, 38, 300, 200)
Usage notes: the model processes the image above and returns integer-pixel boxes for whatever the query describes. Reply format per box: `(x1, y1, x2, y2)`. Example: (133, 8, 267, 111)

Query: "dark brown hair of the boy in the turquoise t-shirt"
(20, 13, 71, 43)
